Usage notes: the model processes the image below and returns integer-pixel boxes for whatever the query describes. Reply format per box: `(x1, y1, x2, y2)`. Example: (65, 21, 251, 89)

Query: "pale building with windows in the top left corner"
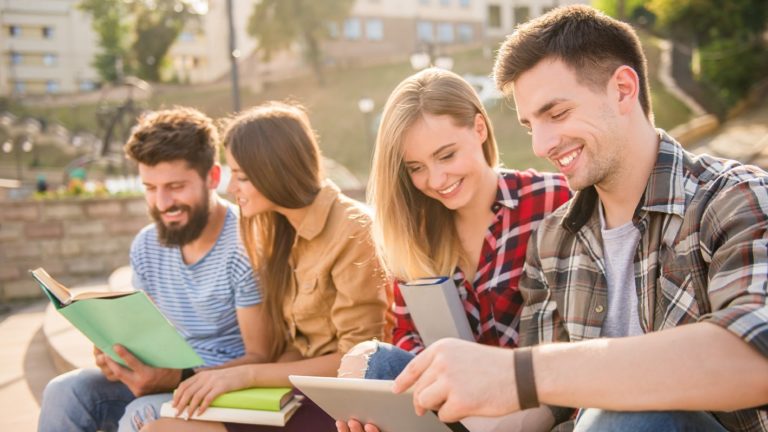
(0, 0, 98, 97)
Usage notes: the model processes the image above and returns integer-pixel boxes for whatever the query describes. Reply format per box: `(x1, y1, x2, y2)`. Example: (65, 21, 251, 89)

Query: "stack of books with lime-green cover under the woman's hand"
(160, 387, 303, 426)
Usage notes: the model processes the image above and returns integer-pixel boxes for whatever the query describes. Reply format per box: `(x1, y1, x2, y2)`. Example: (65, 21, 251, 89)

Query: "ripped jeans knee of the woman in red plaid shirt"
(339, 340, 414, 380)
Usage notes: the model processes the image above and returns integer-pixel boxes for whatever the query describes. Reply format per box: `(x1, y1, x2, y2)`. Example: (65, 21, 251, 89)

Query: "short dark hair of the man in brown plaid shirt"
(494, 5, 651, 118)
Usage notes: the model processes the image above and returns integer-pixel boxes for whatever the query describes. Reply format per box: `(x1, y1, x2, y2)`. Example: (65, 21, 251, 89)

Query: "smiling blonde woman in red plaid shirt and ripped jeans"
(337, 68, 570, 431)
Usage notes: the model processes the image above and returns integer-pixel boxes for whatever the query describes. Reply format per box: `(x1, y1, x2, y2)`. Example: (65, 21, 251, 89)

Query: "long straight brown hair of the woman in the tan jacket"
(224, 102, 322, 360)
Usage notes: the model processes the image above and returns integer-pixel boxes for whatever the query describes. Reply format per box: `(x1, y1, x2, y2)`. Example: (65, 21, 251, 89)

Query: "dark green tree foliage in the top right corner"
(648, 0, 768, 105)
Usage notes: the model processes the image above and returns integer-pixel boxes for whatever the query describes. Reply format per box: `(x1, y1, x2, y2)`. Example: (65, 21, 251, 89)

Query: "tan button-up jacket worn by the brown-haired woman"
(283, 182, 391, 357)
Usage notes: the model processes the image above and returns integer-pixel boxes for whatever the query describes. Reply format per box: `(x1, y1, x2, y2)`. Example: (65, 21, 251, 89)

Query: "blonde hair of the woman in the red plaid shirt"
(368, 68, 499, 281)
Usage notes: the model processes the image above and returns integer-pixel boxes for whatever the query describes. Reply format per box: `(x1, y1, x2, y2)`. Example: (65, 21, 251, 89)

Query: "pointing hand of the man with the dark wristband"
(392, 339, 520, 422)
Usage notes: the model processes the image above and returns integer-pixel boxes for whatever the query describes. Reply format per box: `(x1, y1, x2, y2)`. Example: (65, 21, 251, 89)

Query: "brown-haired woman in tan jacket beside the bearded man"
(146, 102, 390, 431)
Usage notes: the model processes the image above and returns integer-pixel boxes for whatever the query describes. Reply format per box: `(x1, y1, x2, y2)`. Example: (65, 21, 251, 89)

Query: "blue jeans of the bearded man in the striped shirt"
(38, 369, 172, 432)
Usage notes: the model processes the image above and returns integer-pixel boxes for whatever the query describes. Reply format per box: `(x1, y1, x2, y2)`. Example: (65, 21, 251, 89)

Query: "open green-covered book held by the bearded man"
(31, 268, 203, 369)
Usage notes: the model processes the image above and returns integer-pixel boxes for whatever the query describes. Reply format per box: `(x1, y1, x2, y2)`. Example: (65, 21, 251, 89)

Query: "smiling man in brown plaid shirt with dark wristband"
(395, 6, 768, 431)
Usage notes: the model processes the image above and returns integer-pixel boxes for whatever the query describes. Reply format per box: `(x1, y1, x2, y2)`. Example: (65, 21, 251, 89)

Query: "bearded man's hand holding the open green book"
(102, 345, 181, 397)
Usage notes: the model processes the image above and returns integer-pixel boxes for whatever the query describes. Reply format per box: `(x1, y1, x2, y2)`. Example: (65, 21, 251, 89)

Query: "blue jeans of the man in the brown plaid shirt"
(573, 408, 727, 432)
